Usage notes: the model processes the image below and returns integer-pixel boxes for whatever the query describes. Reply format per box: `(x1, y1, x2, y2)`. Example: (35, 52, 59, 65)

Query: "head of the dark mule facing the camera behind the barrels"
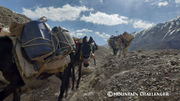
(81, 36, 93, 67)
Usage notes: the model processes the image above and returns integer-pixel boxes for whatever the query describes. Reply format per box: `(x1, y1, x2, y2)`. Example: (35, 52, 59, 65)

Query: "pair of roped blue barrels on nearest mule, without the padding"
(21, 16, 75, 61)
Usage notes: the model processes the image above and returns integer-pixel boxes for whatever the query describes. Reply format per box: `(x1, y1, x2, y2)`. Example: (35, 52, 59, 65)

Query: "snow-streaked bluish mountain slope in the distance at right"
(129, 16, 180, 50)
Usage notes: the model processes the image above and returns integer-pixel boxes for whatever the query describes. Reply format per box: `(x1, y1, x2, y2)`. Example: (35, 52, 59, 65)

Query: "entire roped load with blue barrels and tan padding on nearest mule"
(10, 17, 75, 83)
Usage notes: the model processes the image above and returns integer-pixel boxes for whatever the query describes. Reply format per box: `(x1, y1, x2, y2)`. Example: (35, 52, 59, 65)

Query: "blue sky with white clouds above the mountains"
(0, 0, 180, 45)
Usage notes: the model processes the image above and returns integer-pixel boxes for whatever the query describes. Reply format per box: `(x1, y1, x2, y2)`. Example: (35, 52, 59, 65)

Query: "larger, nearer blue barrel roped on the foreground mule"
(21, 21, 55, 60)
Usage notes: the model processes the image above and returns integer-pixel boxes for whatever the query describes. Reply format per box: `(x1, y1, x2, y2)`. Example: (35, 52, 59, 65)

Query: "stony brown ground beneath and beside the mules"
(1, 47, 180, 101)
